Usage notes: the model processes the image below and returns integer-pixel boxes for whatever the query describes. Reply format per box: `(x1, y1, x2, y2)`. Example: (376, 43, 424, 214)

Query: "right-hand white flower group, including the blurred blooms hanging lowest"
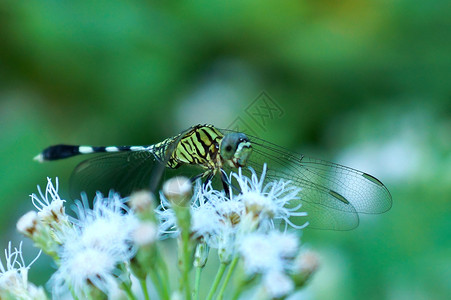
(156, 164, 307, 298)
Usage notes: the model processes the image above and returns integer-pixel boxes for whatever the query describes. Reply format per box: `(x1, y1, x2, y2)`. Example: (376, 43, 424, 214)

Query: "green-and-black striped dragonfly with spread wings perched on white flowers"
(35, 124, 392, 230)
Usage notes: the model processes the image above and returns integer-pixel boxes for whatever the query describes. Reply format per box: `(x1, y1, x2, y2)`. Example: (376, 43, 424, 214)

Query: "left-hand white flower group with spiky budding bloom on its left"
(17, 178, 139, 299)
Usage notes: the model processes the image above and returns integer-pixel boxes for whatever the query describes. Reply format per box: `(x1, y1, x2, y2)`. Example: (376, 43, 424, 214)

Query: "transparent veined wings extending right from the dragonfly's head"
(221, 131, 392, 230)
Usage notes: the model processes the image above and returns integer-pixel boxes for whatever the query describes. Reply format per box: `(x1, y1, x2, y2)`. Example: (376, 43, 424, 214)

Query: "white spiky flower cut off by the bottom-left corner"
(0, 242, 46, 300)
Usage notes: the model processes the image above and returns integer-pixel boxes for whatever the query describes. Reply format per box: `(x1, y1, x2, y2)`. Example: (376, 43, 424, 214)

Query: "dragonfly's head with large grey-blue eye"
(220, 132, 252, 168)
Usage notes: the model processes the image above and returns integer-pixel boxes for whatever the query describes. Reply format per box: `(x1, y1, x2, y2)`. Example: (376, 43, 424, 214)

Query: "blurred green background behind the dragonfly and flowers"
(0, 0, 451, 299)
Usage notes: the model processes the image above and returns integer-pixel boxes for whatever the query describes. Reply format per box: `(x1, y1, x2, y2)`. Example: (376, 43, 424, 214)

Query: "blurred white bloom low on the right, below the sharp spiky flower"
(239, 231, 299, 274)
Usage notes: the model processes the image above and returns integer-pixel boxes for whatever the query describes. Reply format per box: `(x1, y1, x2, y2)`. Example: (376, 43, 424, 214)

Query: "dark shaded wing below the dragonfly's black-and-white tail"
(70, 151, 157, 199)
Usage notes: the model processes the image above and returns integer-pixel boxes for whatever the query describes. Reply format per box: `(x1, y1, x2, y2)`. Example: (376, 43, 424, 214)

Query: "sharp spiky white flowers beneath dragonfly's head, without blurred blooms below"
(155, 164, 307, 260)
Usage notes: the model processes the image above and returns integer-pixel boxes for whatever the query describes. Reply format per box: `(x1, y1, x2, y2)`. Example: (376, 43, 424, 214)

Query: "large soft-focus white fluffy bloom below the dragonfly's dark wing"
(50, 193, 139, 299)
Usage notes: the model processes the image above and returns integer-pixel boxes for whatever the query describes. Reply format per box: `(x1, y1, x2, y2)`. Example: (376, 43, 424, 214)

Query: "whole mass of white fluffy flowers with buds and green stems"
(12, 164, 317, 299)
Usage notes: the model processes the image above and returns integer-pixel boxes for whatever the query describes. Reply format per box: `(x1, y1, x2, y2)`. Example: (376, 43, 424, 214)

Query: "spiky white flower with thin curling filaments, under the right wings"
(232, 164, 307, 229)
